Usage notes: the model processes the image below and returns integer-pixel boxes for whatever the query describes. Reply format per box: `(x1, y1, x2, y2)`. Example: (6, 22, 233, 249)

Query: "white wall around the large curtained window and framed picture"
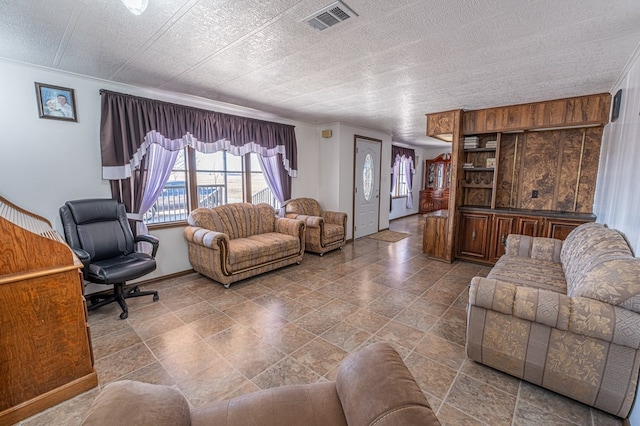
(0, 60, 320, 278)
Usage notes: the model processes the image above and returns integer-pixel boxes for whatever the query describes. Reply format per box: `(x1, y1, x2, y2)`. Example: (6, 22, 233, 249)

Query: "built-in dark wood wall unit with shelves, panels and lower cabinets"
(427, 93, 611, 264)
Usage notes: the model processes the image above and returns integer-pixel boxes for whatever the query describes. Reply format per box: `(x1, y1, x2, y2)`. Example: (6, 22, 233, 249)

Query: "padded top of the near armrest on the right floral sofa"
(469, 277, 640, 349)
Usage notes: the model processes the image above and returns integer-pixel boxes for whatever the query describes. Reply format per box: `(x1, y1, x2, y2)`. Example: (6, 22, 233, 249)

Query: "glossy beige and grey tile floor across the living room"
(21, 216, 621, 426)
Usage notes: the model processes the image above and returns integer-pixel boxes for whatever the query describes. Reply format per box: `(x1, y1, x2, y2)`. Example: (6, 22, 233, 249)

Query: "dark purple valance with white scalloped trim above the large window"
(100, 90, 297, 180)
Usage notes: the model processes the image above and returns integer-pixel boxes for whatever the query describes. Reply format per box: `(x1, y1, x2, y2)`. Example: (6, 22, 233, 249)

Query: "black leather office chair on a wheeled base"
(60, 199, 159, 319)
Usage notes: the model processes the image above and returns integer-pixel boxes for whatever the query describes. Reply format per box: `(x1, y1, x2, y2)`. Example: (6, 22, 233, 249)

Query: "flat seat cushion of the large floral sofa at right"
(487, 254, 567, 293)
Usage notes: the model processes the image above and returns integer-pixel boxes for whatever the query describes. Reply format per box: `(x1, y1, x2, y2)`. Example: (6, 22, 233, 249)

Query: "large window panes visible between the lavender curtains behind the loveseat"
(144, 148, 280, 225)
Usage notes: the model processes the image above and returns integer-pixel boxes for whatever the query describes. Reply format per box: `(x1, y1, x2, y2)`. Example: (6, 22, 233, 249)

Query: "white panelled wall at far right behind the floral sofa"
(593, 45, 640, 425)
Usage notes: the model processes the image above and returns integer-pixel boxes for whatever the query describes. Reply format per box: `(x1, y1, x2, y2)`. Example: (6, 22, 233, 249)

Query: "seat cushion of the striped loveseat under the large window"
(227, 232, 301, 272)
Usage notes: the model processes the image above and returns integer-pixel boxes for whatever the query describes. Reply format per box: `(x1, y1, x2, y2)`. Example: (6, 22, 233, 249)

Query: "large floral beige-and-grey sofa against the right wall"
(466, 223, 640, 418)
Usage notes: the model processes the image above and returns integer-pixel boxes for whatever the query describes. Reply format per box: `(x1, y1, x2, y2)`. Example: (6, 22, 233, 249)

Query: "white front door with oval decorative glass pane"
(353, 136, 382, 239)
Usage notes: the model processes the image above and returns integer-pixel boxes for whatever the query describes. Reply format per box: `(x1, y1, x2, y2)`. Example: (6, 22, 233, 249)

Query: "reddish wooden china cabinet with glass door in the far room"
(418, 154, 451, 214)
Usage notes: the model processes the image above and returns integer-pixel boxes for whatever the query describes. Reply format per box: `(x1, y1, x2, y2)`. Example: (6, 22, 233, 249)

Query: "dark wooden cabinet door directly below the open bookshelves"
(458, 212, 491, 260)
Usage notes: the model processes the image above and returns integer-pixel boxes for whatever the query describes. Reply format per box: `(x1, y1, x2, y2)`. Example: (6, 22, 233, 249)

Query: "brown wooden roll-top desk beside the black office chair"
(0, 197, 98, 424)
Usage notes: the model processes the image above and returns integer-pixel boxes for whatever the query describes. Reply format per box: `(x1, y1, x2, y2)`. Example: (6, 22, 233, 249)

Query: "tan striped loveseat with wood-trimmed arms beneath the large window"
(184, 203, 305, 288)
